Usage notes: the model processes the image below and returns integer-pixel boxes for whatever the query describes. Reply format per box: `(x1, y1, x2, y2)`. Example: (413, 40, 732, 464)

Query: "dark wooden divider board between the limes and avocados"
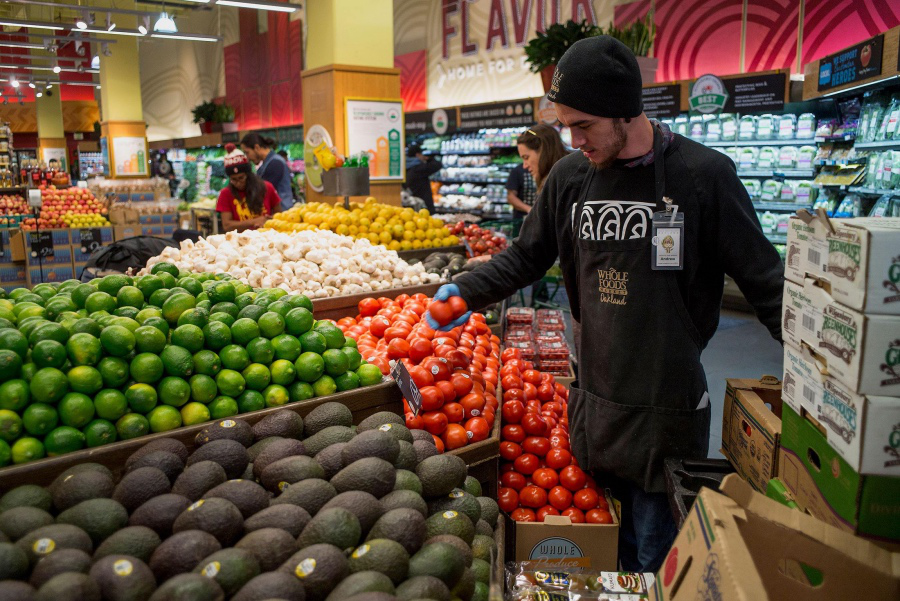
(0, 380, 400, 492)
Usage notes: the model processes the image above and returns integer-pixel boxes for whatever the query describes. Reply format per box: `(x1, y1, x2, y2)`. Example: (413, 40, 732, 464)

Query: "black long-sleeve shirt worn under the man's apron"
(455, 135, 784, 347)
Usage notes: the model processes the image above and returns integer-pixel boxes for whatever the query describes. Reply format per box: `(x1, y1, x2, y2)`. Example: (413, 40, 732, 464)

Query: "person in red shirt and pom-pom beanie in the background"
(216, 144, 281, 232)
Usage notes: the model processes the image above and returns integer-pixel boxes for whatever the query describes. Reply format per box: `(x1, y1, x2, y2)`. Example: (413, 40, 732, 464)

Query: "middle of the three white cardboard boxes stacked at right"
(782, 278, 900, 396)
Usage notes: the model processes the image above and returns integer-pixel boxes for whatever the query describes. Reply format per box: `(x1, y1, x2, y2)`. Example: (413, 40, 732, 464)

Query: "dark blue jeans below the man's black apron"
(595, 474, 678, 573)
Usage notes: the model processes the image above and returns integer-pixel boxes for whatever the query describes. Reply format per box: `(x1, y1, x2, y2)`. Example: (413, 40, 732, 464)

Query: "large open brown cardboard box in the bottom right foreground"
(650, 474, 900, 601)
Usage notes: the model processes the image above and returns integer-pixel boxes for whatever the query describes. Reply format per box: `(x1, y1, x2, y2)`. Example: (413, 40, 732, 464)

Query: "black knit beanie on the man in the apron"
(547, 35, 644, 119)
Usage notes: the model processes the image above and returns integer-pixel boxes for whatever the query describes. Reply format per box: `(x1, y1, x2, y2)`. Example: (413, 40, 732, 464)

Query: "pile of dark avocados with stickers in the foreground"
(0, 402, 499, 601)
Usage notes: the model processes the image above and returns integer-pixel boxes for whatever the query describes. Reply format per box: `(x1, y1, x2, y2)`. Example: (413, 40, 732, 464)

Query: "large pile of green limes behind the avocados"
(0, 263, 381, 466)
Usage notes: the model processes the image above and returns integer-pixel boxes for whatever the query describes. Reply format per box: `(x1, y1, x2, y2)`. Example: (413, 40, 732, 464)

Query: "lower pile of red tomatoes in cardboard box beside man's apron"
(497, 348, 612, 524)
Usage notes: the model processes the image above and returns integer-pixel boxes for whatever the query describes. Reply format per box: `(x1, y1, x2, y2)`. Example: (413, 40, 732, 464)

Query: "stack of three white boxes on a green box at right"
(779, 215, 900, 545)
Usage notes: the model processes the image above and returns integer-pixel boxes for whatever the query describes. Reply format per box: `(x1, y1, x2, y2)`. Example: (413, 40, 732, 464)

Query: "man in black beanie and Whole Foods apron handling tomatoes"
(436, 36, 784, 571)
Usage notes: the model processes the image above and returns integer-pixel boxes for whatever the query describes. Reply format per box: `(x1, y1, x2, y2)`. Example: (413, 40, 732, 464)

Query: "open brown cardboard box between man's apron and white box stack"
(722, 376, 781, 492)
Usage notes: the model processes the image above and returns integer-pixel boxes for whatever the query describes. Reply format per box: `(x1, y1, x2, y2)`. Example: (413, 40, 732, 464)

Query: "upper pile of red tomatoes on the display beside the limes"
(337, 294, 500, 451)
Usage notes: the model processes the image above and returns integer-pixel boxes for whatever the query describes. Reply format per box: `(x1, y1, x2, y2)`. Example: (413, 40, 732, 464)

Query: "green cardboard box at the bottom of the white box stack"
(778, 405, 900, 544)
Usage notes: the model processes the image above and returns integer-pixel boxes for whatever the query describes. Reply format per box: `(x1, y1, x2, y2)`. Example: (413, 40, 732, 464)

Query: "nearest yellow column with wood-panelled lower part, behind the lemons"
(302, 0, 405, 205)
